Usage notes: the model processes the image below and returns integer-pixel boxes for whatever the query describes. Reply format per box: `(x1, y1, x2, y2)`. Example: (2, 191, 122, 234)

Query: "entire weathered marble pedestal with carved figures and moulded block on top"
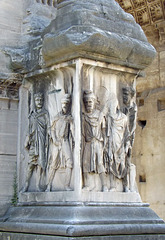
(0, 0, 165, 239)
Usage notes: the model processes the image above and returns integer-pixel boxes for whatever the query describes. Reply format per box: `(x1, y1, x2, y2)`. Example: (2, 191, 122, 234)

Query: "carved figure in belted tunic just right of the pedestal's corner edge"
(83, 90, 108, 191)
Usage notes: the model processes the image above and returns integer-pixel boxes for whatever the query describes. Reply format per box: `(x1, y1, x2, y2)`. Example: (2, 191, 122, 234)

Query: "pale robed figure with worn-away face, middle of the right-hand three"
(107, 98, 130, 191)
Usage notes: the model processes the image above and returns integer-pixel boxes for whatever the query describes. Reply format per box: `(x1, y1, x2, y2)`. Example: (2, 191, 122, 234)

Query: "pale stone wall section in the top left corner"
(0, 0, 23, 73)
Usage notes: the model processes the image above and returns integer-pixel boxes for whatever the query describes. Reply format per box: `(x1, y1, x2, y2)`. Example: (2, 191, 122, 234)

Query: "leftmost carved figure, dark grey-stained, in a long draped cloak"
(22, 93, 49, 192)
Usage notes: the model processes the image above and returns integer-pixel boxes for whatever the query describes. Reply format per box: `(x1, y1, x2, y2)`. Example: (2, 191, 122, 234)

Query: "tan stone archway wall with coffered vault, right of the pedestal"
(116, 0, 165, 220)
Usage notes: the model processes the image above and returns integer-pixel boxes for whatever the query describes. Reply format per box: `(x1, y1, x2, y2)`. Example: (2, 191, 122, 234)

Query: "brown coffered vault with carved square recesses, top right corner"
(116, 0, 165, 44)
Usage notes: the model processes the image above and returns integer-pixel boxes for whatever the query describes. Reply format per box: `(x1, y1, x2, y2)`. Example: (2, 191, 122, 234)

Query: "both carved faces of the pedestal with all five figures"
(20, 60, 137, 197)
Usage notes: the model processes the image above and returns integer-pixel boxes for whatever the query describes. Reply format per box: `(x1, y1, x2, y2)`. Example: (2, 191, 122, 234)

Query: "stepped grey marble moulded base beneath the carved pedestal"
(0, 202, 165, 240)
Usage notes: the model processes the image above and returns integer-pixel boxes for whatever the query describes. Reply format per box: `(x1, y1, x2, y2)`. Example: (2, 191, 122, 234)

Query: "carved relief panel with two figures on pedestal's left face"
(20, 69, 74, 193)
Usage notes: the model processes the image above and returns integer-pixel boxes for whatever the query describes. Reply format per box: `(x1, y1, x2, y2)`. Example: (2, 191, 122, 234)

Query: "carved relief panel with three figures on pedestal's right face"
(82, 63, 137, 192)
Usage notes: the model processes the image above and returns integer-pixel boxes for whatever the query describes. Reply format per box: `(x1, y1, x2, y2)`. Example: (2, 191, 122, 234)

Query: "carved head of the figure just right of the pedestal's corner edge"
(83, 90, 96, 113)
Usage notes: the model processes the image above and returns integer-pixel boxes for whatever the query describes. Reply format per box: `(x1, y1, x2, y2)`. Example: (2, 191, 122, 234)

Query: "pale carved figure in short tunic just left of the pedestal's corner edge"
(46, 94, 74, 192)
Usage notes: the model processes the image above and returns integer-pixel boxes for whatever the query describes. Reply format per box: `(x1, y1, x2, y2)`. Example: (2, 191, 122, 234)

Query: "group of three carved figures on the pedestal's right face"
(82, 87, 137, 192)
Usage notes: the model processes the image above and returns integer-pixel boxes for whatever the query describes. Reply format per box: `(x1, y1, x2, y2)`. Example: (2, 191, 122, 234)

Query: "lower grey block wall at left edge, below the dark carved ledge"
(0, 97, 18, 215)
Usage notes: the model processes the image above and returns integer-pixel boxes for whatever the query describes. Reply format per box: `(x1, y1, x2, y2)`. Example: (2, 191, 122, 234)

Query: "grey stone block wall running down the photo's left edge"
(0, 0, 23, 215)
